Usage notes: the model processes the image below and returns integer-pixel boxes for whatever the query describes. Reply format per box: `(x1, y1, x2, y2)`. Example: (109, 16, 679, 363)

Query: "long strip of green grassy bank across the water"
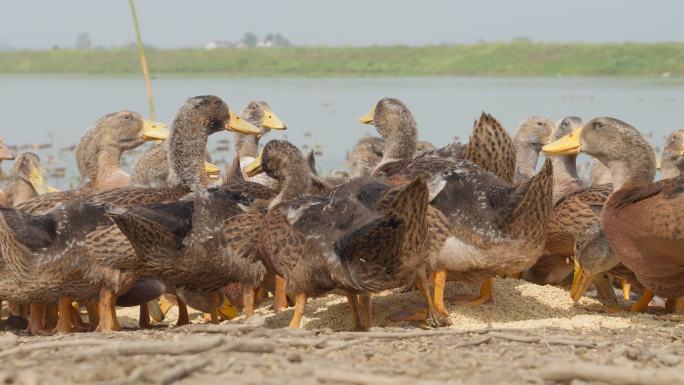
(0, 42, 684, 77)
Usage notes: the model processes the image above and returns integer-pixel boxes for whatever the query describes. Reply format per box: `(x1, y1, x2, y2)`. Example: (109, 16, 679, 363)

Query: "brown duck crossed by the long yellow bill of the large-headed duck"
(523, 116, 612, 285)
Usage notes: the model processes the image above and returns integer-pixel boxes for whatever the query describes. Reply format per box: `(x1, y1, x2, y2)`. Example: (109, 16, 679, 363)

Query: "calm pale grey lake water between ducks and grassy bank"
(0, 76, 684, 188)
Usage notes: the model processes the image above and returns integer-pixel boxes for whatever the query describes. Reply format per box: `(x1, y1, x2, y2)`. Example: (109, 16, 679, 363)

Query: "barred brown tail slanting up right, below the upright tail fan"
(502, 159, 553, 242)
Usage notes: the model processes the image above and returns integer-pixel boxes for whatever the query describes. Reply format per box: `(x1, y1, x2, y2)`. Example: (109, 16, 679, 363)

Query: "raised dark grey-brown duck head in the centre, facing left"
(359, 98, 418, 160)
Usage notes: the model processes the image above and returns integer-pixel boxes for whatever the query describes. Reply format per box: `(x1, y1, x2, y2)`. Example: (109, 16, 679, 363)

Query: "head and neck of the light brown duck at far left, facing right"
(1, 152, 56, 207)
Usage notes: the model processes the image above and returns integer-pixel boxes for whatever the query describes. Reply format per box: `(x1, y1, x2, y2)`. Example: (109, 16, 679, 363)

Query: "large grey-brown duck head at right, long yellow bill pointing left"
(542, 117, 656, 190)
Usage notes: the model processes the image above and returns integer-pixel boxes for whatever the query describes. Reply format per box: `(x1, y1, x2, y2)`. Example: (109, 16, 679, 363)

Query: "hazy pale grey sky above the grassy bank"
(0, 0, 684, 49)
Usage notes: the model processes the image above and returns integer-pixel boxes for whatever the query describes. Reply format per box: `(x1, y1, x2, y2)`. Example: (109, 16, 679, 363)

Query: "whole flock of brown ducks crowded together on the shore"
(0, 96, 684, 334)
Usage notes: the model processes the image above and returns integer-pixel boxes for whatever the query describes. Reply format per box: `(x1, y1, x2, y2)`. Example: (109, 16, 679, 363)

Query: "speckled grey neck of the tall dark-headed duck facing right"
(168, 121, 208, 191)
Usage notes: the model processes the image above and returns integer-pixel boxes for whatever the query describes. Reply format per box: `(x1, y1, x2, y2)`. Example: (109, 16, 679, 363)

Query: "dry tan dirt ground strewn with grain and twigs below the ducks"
(0, 279, 684, 385)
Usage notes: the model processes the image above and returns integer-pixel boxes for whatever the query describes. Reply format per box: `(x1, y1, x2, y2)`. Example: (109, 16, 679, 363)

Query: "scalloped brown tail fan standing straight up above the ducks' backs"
(464, 112, 515, 183)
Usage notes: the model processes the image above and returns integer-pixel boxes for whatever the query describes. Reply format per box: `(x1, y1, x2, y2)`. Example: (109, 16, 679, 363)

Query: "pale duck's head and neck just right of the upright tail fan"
(513, 116, 556, 183)
